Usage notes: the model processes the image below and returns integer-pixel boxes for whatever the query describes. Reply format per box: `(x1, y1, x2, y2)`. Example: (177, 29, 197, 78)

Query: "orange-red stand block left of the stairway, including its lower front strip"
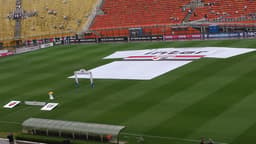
(90, 0, 204, 36)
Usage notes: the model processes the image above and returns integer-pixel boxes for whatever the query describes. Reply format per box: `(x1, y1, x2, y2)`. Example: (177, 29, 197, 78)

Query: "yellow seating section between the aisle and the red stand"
(22, 0, 97, 39)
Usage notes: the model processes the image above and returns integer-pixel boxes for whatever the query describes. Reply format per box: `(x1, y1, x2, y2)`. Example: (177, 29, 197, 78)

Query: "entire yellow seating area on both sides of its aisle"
(0, 0, 97, 39)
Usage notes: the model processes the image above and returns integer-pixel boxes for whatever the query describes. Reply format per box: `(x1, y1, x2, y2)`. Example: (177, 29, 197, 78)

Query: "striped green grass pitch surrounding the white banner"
(0, 39, 256, 144)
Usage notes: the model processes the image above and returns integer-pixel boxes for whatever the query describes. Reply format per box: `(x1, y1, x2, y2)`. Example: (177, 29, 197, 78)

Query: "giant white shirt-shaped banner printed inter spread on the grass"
(69, 47, 255, 80)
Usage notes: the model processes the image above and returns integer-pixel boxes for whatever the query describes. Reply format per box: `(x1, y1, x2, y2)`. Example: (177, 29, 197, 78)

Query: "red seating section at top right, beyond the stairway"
(189, 0, 256, 23)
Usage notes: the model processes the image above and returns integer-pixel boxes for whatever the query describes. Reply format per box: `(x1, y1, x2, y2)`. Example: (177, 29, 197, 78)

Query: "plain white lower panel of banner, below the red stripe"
(69, 61, 191, 80)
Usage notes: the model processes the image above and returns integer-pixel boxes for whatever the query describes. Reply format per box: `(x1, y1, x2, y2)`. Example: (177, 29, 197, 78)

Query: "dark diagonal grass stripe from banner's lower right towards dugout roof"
(89, 61, 218, 123)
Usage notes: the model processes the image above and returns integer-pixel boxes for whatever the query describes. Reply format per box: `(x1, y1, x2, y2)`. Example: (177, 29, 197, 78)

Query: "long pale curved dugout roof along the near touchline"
(22, 118, 125, 136)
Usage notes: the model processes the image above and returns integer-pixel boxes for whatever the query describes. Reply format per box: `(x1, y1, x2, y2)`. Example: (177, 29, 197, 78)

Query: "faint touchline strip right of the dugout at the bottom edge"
(121, 133, 228, 144)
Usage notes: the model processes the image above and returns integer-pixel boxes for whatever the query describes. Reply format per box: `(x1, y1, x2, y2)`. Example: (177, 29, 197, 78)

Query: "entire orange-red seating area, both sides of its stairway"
(90, 0, 256, 37)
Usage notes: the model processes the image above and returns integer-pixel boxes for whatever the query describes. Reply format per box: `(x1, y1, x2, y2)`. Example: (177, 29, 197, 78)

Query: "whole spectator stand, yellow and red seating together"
(0, 0, 256, 46)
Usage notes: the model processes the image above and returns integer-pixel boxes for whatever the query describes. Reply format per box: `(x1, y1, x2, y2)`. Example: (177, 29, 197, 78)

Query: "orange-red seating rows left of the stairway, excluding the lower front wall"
(91, 0, 190, 29)
